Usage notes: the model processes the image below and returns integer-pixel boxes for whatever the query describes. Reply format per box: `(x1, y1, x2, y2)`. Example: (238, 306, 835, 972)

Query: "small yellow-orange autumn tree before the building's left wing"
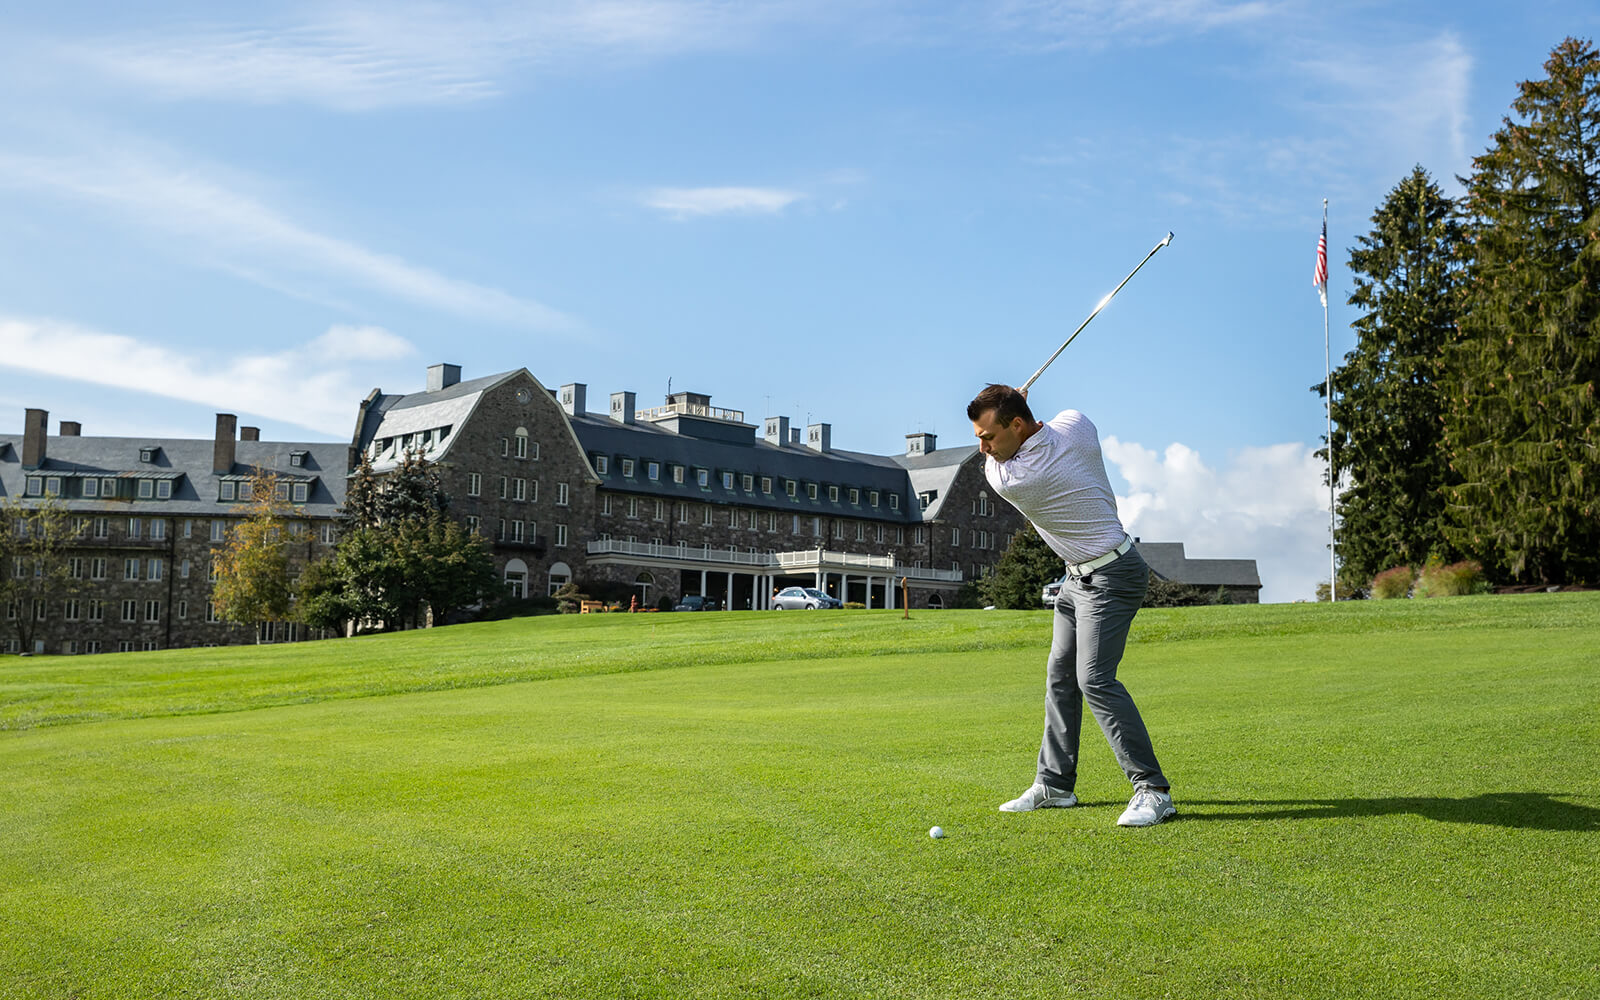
(211, 469, 291, 640)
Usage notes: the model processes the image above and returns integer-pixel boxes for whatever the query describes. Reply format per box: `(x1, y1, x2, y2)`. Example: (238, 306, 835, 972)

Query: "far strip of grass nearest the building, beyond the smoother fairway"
(0, 594, 1600, 731)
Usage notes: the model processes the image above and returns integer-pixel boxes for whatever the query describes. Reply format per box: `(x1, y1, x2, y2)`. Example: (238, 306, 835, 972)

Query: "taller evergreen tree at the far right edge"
(1445, 38, 1600, 582)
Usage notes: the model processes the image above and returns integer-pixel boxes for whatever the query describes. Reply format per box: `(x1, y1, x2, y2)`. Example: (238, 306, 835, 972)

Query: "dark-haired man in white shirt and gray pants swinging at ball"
(966, 384, 1178, 827)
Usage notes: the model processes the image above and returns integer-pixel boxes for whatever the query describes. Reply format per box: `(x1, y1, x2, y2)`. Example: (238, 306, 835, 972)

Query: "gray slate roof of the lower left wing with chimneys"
(0, 434, 349, 517)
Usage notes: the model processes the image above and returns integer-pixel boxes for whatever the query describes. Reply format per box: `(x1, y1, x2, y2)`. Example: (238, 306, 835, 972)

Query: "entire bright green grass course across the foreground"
(0, 594, 1600, 998)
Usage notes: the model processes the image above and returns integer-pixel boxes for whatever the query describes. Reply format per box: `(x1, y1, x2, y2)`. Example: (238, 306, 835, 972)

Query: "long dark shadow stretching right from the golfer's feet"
(1178, 792, 1600, 832)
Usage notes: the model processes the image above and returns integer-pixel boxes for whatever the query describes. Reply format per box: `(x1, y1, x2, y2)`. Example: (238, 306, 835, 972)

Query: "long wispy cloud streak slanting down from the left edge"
(0, 154, 573, 330)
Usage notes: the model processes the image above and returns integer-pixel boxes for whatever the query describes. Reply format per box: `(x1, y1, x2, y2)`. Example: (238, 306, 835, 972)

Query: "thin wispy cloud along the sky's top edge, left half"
(58, 0, 800, 110)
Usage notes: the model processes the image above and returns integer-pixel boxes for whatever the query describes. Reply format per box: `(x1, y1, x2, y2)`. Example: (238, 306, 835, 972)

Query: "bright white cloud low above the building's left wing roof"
(0, 317, 416, 434)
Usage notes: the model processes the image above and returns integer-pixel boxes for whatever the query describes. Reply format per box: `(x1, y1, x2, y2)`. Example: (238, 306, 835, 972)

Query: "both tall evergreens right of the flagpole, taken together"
(1312, 38, 1600, 592)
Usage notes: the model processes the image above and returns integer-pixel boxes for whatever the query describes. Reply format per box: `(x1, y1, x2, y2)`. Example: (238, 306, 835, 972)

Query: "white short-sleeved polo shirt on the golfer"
(984, 410, 1126, 563)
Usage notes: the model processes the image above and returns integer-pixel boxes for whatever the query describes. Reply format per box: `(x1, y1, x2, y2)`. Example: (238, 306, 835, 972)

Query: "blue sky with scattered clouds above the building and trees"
(0, 0, 1600, 600)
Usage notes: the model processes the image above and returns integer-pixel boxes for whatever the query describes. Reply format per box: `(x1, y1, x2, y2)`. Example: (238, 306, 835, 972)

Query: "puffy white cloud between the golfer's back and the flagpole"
(1102, 437, 1328, 602)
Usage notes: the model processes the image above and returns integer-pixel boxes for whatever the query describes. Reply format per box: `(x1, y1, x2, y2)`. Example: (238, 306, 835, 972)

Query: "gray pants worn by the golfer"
(1038, 547, 1168, 792)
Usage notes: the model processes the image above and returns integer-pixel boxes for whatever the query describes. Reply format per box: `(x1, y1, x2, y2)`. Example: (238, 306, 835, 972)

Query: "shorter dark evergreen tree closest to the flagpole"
(1312, 166, 1462, 590)
